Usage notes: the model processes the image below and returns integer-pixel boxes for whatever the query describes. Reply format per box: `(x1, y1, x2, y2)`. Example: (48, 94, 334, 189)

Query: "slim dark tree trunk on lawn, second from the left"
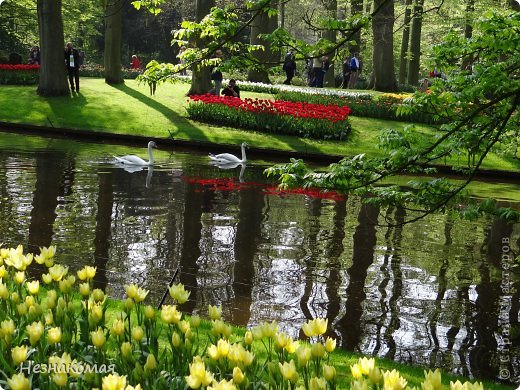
(105, 0, 123, 84)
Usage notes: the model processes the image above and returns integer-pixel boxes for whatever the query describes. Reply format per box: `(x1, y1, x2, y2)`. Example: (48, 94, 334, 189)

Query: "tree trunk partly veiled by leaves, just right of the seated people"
(247, 0, 278, 84)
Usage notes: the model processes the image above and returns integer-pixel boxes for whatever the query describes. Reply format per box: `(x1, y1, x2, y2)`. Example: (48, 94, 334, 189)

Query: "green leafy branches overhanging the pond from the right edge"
(267, 12, 520, 221)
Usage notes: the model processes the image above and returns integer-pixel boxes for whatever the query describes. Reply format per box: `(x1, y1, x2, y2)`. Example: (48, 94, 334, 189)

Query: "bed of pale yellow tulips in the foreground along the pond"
(0, 246, 492, 390)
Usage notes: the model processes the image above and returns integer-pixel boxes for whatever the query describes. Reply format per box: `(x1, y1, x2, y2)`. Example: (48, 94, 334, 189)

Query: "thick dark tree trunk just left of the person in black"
(37, 0, 70, 96)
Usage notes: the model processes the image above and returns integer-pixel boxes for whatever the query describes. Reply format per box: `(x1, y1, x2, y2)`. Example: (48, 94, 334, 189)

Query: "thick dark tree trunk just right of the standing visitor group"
(369, 0, 397, 92)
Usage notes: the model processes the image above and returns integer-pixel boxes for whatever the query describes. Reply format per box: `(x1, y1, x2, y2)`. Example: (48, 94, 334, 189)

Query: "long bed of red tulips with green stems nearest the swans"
(186, 94, 351, 140)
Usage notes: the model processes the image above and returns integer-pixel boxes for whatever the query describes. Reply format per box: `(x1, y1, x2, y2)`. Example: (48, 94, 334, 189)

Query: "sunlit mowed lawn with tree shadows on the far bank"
(0, 77, 520, 171)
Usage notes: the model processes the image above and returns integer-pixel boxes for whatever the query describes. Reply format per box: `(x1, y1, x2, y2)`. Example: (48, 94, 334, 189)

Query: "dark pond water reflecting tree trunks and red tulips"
(0, 133, 520, 382)
